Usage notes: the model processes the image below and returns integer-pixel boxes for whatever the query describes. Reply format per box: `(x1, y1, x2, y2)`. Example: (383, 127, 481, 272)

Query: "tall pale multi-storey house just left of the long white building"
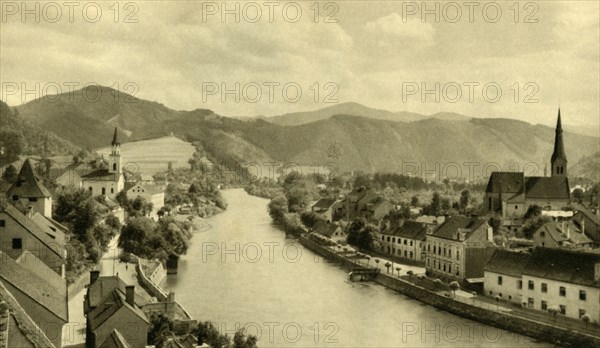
(425, 215, 494, 282)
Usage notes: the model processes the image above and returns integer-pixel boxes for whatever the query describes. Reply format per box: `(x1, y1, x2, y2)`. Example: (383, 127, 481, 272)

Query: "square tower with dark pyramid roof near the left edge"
(6, 159, 52, 217)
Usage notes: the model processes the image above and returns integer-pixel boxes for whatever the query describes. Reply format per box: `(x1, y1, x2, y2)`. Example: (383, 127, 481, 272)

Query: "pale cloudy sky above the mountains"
(0, 0, 600, 126)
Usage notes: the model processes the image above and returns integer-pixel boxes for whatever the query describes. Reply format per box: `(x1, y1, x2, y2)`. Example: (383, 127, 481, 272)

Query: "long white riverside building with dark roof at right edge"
(484, 247, 600, 323)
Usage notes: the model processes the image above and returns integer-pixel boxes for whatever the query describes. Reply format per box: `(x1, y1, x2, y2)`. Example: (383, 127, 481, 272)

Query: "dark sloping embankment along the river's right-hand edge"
(298, 236, 600, 347)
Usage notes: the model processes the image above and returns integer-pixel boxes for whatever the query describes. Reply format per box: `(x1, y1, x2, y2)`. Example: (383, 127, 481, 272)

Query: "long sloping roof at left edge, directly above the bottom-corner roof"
(0, 251, 69, 322)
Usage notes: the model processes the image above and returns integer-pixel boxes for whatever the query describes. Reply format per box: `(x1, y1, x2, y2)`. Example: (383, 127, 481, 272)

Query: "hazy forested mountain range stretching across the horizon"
(3, 86, 599, 180)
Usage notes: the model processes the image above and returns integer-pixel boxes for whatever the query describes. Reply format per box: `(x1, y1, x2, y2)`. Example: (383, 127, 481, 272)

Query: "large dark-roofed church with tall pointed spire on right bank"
(484, 109, 570, 219)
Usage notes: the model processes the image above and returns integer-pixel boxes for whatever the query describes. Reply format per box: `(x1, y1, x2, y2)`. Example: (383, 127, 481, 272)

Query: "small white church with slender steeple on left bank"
(81, 127, 125, 198)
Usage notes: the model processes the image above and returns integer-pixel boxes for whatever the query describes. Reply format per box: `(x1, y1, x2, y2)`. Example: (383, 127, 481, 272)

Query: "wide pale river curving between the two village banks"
(163, 189, 546, 347)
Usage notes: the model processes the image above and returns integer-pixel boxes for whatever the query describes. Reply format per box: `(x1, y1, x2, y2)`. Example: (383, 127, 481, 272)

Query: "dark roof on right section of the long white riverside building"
(523, 247, 600, 288)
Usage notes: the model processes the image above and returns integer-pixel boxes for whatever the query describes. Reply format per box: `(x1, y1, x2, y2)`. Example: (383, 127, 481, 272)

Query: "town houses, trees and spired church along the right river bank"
(271, 110, 600, 325)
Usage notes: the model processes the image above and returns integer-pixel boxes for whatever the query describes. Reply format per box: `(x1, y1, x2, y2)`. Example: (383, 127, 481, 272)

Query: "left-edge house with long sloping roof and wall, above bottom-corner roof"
(0, 251, 69, 347)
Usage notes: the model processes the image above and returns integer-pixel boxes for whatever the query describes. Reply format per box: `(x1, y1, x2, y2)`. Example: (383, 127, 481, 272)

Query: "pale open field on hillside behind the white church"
(97, 136, 196, 175)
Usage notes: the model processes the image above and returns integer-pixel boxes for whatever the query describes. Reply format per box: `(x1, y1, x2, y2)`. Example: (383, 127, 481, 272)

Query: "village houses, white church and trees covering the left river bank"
(0, 128, 250, 348)
